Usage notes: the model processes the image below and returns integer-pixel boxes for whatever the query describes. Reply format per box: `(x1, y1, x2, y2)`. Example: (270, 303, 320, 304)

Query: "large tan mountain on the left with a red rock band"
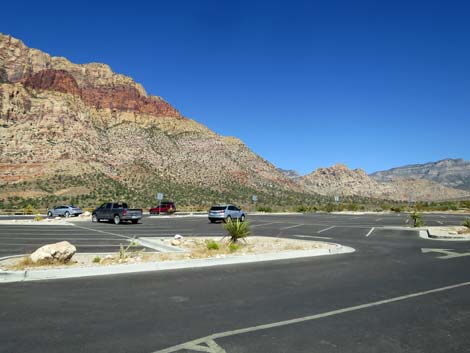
(0, 34, 300, 206)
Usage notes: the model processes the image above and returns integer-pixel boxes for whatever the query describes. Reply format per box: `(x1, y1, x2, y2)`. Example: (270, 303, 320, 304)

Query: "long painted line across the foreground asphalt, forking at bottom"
(152, 282, 470, 353)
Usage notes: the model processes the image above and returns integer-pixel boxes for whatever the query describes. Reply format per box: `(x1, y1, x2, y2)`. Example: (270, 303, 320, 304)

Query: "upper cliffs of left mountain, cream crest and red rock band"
(0, 34, 182, 118)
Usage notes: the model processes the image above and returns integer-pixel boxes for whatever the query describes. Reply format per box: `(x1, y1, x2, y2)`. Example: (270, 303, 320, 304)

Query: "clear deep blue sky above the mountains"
(0, 0, 470, 174)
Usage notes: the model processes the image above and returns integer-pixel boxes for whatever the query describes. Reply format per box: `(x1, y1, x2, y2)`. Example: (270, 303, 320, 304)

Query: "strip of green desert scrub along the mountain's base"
(0, 170, 470, 214)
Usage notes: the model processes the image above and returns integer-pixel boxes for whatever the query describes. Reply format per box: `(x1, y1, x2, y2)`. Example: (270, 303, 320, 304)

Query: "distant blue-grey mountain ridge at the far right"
(370, 159, 470, 191)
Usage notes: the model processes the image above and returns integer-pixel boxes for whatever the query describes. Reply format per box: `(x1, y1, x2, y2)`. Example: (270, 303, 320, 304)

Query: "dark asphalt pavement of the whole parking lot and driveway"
(0, 214, 470, 353)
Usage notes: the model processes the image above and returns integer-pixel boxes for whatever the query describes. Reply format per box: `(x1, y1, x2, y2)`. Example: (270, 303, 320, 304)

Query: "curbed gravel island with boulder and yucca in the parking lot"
(0, 236, 354, 282)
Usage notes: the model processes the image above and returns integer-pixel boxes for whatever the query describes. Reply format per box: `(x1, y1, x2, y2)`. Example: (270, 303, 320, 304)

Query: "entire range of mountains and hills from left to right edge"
(0, 34, 470, 208)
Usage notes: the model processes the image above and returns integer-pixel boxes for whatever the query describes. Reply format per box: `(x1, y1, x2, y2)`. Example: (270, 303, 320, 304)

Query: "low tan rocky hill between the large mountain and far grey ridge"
(299, 164, 470, 201)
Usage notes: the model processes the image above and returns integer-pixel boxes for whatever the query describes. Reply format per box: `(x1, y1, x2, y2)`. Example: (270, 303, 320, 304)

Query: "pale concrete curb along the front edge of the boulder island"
(0, 244, 355, 284)
